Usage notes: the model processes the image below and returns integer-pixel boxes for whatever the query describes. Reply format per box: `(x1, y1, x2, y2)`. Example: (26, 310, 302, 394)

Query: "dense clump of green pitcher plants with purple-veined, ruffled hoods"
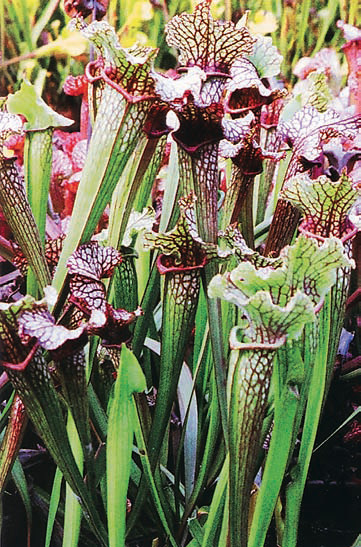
(0, 0, 361, 547)
